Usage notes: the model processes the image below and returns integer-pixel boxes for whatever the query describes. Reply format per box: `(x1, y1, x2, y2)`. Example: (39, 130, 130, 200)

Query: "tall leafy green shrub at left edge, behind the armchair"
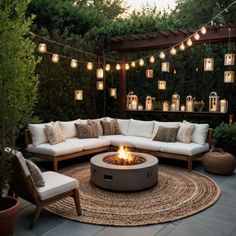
(0, 0, 38, 196)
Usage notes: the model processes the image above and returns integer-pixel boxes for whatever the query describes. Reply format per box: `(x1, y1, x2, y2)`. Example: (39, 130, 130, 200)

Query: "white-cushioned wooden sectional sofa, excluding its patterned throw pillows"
(25, 117, 212, 171)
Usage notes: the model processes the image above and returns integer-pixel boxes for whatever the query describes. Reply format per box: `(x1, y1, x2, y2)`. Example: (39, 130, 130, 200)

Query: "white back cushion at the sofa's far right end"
(183, 120, 209, 144)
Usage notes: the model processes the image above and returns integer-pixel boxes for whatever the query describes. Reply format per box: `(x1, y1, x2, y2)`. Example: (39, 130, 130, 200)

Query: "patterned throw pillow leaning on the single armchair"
(25, 159, 45, 188)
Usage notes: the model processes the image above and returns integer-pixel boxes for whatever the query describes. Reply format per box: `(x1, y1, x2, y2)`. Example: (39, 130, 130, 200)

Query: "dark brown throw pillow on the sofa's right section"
(153, 126, 179, 142)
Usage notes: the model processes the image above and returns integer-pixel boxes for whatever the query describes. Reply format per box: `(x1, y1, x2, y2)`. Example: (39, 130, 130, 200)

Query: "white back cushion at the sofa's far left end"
(28, 122, 52, 146)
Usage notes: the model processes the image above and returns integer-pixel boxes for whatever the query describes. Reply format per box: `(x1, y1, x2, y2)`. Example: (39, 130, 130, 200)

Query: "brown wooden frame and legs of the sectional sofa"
(25, 128, 213, 171)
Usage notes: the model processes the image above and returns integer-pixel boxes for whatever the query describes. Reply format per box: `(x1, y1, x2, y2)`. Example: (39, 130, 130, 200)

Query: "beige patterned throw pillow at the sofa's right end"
(176, 123, 195, 143)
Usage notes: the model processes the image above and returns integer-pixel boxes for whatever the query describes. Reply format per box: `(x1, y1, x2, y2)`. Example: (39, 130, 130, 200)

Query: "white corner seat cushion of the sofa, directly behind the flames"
(99, 135, 134, 147)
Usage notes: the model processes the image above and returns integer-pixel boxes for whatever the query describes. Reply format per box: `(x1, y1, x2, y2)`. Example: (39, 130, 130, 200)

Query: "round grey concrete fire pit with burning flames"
(90, 147, 158, 191)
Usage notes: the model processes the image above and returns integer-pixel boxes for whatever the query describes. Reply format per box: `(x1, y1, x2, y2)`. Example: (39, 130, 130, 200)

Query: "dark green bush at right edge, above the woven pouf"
(213, 122, 236, 156)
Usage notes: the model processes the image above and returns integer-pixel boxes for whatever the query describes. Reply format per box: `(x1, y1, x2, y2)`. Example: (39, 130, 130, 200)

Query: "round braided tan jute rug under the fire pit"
(46, 163, 220, 226)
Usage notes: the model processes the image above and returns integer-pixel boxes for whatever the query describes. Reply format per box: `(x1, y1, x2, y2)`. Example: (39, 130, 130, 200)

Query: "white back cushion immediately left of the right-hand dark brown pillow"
(127, 119, 154, 138)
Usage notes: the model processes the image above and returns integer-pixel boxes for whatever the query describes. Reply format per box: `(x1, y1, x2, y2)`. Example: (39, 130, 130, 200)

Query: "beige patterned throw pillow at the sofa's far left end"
(45, 121, 65, 145)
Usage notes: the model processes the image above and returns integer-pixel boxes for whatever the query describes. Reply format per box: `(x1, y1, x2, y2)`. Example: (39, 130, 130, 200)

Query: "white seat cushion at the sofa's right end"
(160, 142, 209, 156)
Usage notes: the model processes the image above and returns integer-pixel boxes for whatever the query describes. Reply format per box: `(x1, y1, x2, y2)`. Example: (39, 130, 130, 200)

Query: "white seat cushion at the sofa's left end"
(26, 138, 83, 156)
